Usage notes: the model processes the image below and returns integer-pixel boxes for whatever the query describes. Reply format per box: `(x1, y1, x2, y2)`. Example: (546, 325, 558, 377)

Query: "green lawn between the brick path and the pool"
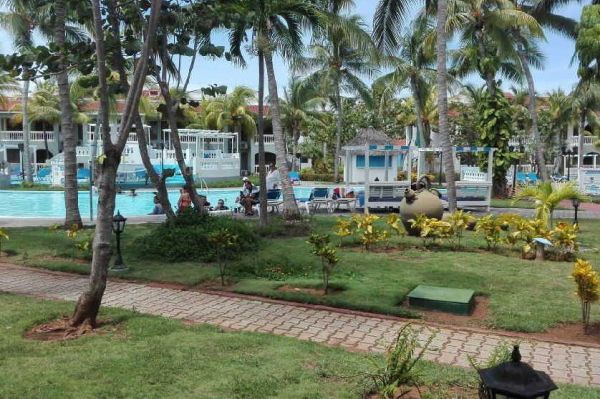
(5, 217, 600, 332)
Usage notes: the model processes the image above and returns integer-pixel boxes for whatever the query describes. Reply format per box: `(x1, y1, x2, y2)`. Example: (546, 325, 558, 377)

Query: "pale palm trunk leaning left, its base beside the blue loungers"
(264, 52, 300, 219)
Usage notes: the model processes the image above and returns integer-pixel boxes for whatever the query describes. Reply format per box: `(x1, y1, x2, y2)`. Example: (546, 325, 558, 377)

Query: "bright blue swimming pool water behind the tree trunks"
(0, 187, 311, 218)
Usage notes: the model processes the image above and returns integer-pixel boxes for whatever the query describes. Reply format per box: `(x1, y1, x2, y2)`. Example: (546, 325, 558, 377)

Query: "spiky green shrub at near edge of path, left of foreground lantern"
(369, 324, 434, 399)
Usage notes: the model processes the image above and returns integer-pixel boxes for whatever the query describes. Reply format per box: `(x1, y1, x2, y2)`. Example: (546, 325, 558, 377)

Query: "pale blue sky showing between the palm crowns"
(0, 0, 583, 96)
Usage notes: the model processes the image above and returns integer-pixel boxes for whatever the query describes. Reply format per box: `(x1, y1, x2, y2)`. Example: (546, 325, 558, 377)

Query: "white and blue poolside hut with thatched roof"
(343, 128, 411, 212)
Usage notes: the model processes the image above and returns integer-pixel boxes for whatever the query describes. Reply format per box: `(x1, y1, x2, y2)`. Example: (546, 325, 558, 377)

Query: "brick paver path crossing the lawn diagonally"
(0, 264, 600, 387)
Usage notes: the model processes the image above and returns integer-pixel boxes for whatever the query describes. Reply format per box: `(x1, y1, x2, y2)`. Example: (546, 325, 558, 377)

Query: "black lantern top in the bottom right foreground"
(479, 345, 558, 399)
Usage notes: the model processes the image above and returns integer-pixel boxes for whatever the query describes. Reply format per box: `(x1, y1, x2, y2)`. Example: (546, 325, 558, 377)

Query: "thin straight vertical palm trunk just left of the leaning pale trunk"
(258, 50, 269, 227)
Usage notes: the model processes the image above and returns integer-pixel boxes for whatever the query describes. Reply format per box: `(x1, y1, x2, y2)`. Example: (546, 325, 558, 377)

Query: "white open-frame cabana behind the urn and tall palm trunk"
(417, 146, 496, 211)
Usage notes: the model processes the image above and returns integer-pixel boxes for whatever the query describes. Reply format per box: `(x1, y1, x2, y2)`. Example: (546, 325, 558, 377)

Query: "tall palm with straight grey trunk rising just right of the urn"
(373, 0, 456, 212)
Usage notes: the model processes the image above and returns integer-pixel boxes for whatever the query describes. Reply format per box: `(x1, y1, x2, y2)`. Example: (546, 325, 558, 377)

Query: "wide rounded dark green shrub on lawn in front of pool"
(133, 212, 259, 262)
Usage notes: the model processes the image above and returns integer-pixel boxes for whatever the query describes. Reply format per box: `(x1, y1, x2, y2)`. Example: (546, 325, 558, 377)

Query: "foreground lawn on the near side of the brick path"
(0, 294, 600, 399)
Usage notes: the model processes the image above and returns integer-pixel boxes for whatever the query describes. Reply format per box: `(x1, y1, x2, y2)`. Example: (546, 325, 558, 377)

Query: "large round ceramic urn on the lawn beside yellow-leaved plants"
(400, 188, 444, 236)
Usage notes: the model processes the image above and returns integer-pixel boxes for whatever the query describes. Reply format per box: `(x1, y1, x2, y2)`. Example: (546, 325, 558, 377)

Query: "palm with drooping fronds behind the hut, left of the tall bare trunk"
(374, 17, 436, 146)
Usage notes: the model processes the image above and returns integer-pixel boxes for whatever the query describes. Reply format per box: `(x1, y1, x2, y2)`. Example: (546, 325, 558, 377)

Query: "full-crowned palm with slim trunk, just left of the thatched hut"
(295, 0, 377, 181)
